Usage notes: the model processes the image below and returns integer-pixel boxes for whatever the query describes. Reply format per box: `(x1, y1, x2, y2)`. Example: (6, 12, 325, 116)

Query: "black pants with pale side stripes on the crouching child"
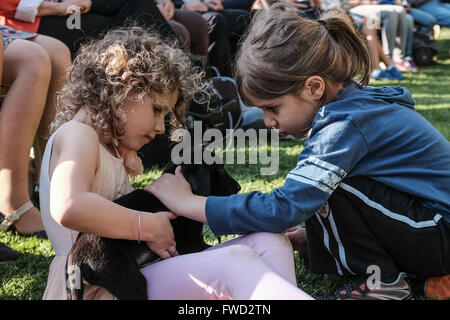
(306, 177, 450, 283)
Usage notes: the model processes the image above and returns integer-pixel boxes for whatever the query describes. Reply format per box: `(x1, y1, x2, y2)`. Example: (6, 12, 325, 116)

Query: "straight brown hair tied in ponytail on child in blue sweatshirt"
(236, 5, 371, 101)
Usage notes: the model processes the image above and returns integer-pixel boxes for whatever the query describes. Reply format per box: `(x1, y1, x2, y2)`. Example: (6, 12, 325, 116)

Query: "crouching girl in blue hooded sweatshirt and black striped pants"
(147, 6, 450, 299)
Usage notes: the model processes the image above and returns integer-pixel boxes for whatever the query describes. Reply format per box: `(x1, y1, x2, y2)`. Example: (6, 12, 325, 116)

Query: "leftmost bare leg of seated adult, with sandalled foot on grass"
(0, 39, 51, 234)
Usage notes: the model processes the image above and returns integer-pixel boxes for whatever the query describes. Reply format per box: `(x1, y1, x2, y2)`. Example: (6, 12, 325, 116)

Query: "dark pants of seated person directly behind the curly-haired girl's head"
(38, 0, 177, 56)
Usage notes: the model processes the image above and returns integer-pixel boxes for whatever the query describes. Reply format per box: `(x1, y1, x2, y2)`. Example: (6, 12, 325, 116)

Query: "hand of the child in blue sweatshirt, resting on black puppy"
(144, 166, 207, 222)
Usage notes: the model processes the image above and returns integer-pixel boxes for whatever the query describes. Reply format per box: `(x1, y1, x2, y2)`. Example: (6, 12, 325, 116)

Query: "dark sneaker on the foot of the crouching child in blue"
(324, 272, 411, 300)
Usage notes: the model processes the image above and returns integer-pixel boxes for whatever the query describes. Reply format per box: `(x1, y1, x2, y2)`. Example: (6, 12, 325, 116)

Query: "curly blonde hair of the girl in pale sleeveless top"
(50, 26, 205, 141)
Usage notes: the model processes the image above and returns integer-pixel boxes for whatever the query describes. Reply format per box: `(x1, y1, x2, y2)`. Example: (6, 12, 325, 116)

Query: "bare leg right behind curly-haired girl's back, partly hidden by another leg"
(32, 35, 71, 182)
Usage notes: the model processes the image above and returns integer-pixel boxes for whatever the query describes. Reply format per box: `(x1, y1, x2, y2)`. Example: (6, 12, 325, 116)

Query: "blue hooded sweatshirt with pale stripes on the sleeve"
(206, 82, 450, 235)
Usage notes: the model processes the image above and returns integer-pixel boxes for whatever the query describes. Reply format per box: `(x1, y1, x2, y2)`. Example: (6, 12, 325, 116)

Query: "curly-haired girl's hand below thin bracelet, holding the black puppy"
(141, 211, 178, 259)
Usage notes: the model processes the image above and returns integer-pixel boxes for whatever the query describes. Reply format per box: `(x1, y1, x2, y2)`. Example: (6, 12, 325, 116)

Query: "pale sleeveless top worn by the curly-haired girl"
(40, 120, 132, 300)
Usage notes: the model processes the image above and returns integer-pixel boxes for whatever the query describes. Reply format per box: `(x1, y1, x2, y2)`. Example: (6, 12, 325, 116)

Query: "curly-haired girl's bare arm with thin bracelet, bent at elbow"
(49, 125, 176, 258)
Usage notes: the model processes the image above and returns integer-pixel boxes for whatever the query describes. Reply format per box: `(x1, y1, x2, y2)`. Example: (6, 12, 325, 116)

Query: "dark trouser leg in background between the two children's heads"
(199, 9, 251, 77)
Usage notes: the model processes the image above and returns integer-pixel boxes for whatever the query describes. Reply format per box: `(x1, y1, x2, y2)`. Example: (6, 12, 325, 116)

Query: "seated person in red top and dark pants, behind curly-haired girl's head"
(0, 0, 177, 56)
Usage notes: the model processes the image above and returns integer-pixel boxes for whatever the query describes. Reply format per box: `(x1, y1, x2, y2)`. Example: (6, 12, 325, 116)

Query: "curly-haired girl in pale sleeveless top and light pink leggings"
(41, 27, 309, 299)
